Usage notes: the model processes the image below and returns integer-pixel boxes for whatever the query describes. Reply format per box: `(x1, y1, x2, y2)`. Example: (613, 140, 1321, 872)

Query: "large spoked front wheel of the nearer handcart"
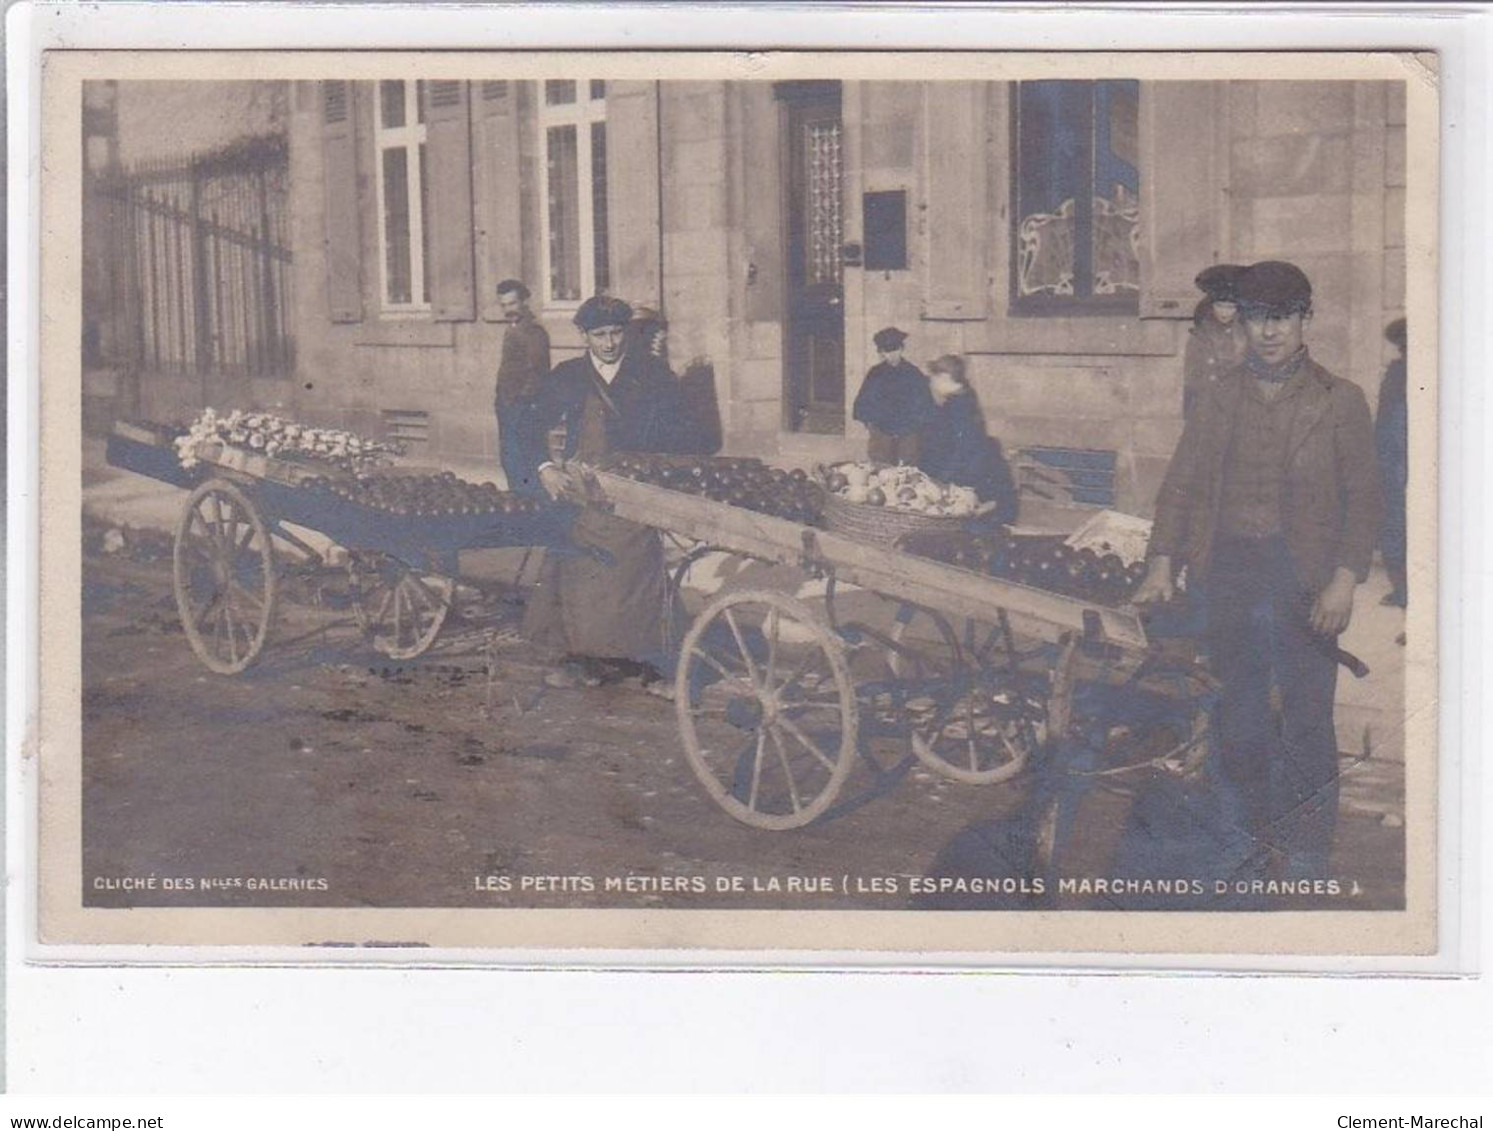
(675, 589, 857, 830)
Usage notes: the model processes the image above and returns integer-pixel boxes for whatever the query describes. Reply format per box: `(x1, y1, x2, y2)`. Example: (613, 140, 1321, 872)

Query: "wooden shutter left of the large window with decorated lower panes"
(923, 82, 990, 321)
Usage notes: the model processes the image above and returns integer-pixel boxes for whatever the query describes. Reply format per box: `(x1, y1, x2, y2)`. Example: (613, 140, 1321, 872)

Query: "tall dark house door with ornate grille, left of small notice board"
(776, 82, 845, 434)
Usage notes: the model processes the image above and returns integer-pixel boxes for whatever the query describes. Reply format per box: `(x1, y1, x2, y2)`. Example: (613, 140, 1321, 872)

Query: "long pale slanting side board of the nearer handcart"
(596, 471, 1148, 651)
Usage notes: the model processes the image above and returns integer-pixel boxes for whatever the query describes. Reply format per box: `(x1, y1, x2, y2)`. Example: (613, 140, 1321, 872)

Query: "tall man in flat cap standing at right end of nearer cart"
(1135, 261, 1383, 879)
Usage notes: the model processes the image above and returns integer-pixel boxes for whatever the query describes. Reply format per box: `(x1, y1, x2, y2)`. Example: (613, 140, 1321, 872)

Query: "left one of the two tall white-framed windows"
(376, 81, 430, 310)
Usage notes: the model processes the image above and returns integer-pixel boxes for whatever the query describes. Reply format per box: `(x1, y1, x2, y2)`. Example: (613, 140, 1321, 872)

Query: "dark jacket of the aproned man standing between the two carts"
(530, 341, 688, 470)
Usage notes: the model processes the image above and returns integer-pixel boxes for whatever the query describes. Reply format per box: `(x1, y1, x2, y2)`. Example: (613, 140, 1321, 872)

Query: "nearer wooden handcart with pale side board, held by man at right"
(585, 470, 1214, 830)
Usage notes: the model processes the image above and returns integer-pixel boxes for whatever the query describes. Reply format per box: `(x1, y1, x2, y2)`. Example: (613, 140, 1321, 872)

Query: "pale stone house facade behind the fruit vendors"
(274, 82, 1405, 513)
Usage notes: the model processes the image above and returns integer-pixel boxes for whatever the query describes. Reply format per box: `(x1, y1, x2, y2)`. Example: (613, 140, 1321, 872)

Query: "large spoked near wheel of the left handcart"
(172, 479, 276, 676)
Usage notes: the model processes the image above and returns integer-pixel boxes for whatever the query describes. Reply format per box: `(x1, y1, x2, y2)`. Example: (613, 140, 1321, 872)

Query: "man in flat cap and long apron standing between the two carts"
(524, 295, 678, 686)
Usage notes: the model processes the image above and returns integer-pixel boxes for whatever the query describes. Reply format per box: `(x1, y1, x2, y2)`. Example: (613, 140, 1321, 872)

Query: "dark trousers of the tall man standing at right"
(1206, 537, 1338, 879)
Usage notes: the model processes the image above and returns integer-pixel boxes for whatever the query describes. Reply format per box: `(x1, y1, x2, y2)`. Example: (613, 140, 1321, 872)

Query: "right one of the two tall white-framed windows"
(539, 79, 612, 306)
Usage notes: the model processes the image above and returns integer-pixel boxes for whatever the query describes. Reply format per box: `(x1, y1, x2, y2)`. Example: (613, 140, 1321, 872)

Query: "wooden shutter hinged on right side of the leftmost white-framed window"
(426, 81, 475, 322)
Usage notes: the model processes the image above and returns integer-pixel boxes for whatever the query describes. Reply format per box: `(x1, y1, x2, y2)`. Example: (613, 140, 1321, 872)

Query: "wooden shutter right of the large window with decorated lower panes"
(1141, 82, 1229, 318)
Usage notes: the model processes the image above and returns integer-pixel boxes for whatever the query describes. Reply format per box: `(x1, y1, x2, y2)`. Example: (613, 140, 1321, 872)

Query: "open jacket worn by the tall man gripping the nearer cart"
(1150, 358, 1384, 589)
